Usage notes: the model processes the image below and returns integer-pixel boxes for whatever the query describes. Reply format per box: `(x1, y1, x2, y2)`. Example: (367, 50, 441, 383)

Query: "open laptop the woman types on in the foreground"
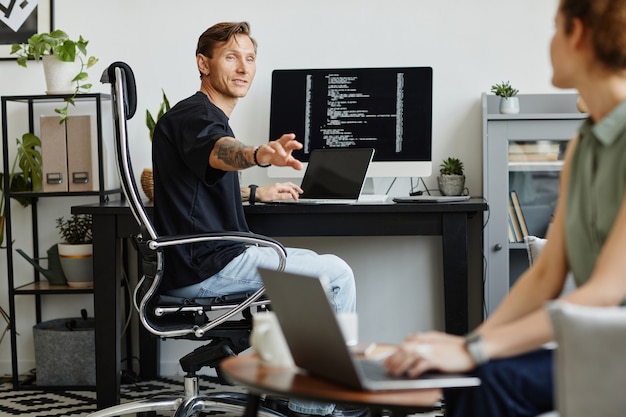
(259, 268, 480, 391)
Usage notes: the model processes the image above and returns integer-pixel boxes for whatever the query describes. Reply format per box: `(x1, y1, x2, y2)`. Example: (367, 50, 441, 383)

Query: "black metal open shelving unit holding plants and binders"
(1, 93, 122, 388)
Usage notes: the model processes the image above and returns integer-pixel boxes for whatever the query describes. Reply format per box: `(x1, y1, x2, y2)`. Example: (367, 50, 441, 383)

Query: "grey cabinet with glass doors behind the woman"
(482, 94, 587, 315)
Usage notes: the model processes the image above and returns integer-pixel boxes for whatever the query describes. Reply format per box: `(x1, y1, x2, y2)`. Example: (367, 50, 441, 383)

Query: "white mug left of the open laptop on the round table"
(250, 311, 295, 367)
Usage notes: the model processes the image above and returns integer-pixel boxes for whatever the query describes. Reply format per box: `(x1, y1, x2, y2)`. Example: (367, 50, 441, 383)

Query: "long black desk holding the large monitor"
(72, 198, 487, 409)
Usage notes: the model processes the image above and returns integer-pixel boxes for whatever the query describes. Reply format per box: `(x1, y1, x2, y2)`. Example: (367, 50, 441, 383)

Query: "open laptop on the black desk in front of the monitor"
(276, 148, 374, 204)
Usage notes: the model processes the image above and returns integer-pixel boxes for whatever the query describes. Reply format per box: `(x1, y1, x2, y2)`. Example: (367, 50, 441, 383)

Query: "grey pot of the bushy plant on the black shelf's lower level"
(59, 243, 93, 288)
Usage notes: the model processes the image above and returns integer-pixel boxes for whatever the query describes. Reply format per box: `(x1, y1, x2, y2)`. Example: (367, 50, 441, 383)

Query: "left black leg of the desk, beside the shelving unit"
(93, 215, 122, 410)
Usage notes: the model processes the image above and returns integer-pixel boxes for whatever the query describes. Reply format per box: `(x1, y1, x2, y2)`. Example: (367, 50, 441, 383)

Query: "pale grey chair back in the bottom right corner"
(548, 301, 626, 417)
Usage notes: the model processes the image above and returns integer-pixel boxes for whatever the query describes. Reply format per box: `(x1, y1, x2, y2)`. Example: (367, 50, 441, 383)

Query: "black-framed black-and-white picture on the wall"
(0, 0, 54, 60)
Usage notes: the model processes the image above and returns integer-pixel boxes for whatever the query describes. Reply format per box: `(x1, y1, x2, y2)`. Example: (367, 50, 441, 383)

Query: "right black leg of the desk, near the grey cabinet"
(442, 213, 469, 335)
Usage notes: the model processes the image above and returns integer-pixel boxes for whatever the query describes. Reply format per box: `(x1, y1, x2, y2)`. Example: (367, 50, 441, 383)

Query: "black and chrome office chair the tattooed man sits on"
(90, 62, 287, 417)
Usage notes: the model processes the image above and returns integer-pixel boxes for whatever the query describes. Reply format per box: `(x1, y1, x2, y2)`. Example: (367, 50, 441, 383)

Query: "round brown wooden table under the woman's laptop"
(221, 355, 441, 417)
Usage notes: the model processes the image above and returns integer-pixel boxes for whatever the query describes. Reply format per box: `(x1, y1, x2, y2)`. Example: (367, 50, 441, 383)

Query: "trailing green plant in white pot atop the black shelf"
(11, 29, 98, 122)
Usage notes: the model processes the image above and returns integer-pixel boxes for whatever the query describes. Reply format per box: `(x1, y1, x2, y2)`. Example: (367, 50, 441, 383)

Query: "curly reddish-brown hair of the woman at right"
(561, 0, 626, 70)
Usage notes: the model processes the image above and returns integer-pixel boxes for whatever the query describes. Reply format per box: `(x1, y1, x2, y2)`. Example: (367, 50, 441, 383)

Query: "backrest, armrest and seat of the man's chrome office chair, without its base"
(101, 62, 286, 338)
